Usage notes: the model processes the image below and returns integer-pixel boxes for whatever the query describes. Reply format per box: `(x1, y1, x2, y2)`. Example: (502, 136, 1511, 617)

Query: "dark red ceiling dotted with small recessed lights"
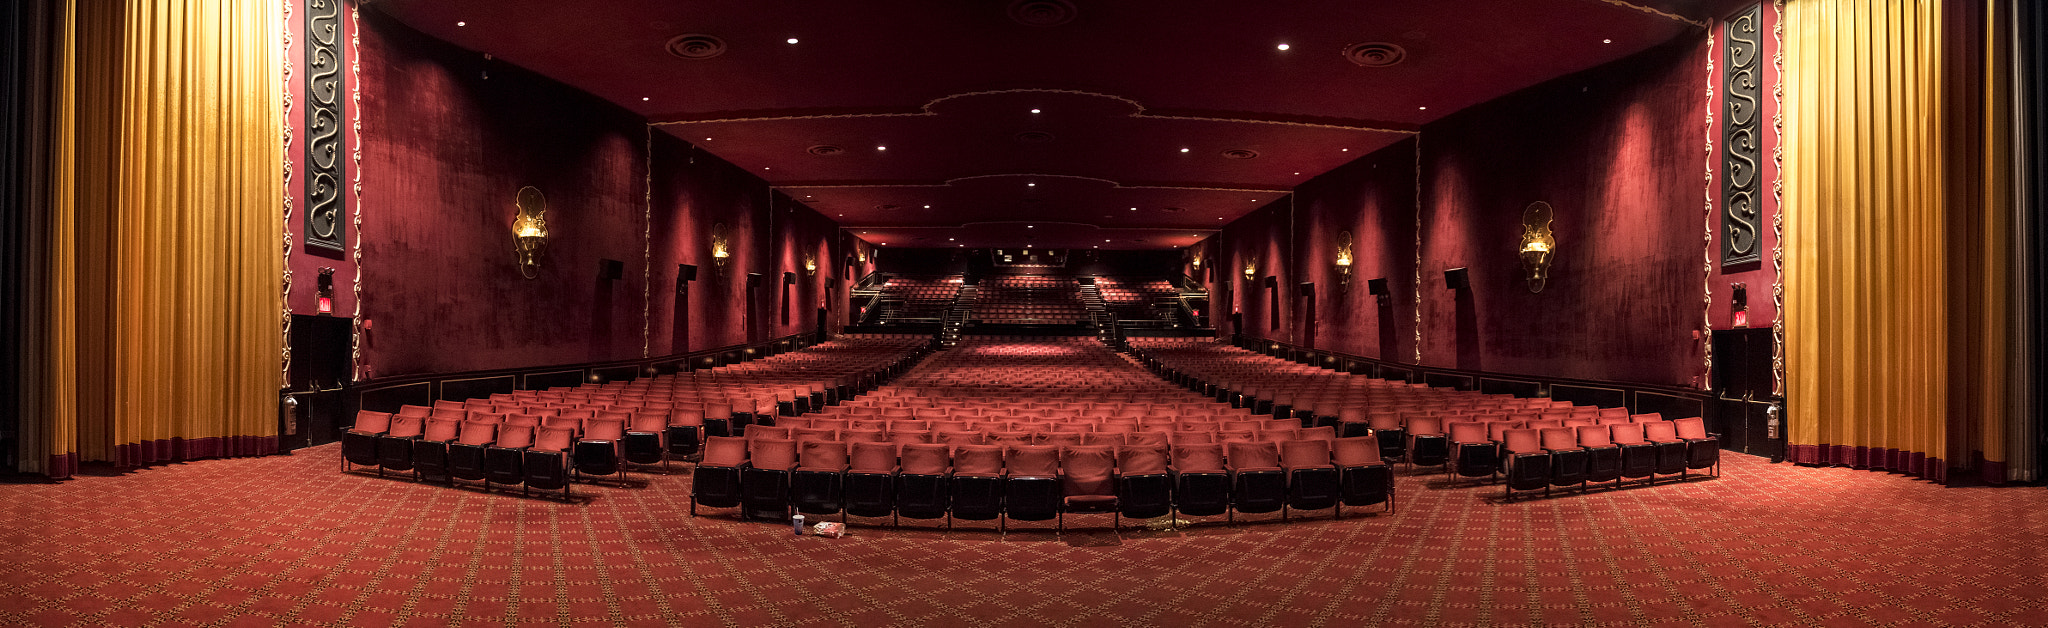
(377, 0, 1745, 250)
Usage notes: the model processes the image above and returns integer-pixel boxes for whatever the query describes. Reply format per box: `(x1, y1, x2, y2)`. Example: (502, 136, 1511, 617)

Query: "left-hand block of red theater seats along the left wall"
(342, 338, 924, 499)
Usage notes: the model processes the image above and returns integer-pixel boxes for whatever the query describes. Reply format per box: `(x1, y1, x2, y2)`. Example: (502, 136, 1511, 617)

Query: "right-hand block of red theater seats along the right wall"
(1135, 340, 1720, 499)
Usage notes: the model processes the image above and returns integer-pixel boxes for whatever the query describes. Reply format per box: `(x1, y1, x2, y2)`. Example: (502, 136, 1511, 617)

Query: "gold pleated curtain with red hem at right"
(1786, 0, 2013, 481)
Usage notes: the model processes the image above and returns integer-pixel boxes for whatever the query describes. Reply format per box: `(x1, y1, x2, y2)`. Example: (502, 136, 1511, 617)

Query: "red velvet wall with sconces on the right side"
(1219, 33, 1720, 385)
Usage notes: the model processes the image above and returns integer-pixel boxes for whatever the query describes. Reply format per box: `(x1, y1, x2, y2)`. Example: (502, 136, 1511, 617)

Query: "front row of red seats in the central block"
(690, 428, 1393, 530)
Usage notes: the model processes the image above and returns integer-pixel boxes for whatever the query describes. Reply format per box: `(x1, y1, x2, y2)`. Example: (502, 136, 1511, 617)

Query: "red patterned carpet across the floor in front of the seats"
(0, 446, 2048, 626)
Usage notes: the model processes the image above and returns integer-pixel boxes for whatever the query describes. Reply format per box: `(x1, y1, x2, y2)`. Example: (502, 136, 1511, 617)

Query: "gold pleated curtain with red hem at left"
(35, 0, 283, 477)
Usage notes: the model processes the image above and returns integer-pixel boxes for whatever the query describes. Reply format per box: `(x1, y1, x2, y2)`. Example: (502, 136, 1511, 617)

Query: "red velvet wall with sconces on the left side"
(362, 12, 836, 376)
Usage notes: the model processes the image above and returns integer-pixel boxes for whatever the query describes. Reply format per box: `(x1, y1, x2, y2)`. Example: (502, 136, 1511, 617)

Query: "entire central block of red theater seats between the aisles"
(692, 338, 1395, 528)
